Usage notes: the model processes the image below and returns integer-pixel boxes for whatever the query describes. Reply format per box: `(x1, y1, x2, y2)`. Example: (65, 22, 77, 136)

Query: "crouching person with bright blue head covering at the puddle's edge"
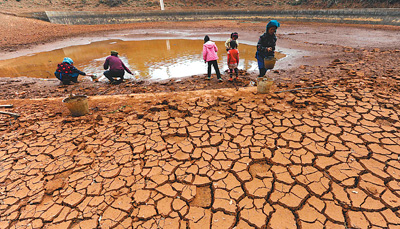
(54, 57, 86, 85)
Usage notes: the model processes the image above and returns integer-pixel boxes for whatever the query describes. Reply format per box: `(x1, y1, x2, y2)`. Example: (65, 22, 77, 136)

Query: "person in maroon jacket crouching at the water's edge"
(103, 51, 133, 84)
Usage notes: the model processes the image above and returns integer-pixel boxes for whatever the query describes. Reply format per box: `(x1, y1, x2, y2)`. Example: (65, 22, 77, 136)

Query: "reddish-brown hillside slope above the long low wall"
(0, 0, 400, 14)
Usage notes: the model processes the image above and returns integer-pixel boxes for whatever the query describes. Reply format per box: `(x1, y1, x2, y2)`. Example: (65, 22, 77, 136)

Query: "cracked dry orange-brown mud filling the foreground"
(0, 47, 400, 228)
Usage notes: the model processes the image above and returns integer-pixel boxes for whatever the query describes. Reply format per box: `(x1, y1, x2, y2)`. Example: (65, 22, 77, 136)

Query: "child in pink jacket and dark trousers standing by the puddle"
(203, 35, 222, 81)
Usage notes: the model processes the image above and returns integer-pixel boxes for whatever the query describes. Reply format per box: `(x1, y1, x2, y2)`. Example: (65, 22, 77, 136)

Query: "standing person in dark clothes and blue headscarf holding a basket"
(256, 20, 280, 77)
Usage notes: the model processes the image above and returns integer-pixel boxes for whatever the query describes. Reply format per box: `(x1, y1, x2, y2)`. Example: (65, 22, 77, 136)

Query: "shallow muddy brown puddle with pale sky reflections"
(0, 39, 285, 80)
